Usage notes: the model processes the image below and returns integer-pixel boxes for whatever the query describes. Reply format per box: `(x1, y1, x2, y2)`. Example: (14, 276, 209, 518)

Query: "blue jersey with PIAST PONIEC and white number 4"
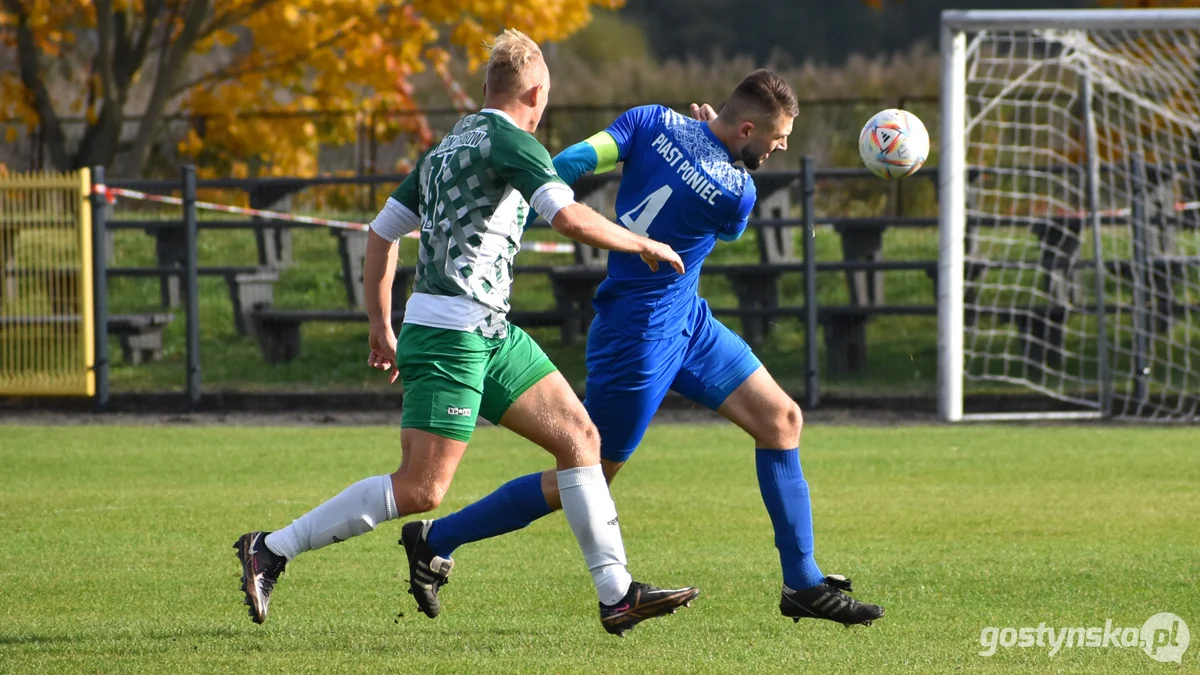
(556, 106, 755, 340)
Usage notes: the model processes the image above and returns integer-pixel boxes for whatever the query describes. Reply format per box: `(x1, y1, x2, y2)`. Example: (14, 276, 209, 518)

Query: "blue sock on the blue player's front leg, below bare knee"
(755, 448, 824, 591)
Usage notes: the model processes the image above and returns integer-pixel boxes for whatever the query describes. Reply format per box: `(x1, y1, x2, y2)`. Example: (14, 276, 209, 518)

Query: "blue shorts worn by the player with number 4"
(583, 300, 762, 461)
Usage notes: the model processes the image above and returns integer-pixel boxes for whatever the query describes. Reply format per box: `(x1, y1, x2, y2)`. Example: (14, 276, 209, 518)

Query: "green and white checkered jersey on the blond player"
(392, 109, 569, 338)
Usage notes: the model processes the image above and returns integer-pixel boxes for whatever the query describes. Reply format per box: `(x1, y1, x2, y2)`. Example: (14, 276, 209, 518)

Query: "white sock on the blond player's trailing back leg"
(266, 476, 400, 560)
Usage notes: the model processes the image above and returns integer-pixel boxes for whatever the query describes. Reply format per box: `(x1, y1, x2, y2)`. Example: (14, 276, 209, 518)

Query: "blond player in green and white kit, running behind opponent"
(234, 30, 698, 634)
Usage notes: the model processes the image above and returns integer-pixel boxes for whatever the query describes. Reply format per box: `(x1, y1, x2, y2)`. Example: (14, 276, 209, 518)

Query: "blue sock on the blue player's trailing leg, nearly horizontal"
(427, 473, 550, 557)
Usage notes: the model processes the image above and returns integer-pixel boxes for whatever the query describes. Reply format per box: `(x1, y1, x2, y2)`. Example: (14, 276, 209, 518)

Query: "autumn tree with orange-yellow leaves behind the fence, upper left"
(0, 0, 622, 175)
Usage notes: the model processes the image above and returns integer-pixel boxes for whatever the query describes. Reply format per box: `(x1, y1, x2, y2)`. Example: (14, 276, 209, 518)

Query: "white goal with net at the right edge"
(937, 10, 1200, 422)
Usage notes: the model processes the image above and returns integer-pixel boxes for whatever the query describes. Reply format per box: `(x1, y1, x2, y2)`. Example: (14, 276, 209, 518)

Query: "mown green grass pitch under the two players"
(0, 425, 1200, 674)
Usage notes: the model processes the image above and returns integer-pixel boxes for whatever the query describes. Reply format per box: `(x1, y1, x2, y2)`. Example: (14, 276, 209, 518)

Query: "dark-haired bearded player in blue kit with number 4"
(401, 70, 883, 626)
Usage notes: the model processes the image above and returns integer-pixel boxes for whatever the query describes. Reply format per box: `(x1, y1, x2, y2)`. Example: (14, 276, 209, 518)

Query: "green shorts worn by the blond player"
(396, 323, 557, 442)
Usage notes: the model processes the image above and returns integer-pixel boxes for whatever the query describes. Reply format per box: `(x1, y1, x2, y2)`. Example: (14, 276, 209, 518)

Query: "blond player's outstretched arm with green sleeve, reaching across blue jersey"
(492, 126, 684, 274)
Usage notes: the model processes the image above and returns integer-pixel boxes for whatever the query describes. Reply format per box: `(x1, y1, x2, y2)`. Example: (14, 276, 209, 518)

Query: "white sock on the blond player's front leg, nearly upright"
(558, 465, 632, 604)
